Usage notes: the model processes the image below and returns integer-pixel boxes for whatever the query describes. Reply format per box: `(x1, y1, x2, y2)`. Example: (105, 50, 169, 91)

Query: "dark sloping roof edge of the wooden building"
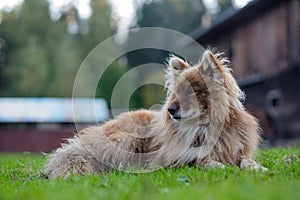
(190, 0, 289, 44)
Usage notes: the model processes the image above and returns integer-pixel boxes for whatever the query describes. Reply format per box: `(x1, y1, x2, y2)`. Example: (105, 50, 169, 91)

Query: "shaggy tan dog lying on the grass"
(44, 50, 267, 178)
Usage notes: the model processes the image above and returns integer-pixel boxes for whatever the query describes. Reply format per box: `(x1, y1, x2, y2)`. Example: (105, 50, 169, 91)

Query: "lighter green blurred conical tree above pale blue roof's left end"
(6, 37, 49, 96)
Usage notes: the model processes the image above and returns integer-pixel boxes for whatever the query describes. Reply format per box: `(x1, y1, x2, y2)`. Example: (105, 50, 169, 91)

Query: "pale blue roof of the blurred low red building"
(0, 98, 109, 123)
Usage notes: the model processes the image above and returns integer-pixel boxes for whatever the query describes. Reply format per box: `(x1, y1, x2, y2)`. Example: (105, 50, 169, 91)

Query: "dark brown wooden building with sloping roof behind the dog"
(191, 0, 300, 144)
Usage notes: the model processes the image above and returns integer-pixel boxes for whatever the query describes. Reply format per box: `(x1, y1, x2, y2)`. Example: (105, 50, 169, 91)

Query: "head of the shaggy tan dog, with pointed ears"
(165, 51, 243, 125)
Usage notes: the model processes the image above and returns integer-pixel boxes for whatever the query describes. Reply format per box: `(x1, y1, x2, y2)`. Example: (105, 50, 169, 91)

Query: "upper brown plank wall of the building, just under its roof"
(213, 0, 300, 79)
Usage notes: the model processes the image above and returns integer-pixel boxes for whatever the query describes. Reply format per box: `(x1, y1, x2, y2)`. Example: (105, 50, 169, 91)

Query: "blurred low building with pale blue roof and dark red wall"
(0, 98, 109, 152)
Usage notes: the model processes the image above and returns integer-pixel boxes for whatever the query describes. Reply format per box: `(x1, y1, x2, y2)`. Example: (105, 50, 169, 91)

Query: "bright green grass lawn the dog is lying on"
(0, 148, 300, 200)
